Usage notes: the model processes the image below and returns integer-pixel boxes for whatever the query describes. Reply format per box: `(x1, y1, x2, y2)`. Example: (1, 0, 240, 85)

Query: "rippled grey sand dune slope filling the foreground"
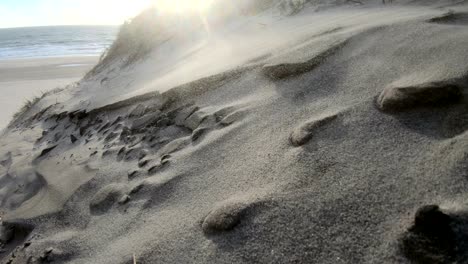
(0, 0, 468, 264)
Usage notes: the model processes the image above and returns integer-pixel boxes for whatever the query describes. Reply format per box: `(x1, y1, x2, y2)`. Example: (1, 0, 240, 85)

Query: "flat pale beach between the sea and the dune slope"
(0, 56, 98, 130)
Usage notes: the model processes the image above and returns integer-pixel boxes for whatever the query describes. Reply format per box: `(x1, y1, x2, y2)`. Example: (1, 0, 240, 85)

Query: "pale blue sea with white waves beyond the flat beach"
(0, 26, 118, 60)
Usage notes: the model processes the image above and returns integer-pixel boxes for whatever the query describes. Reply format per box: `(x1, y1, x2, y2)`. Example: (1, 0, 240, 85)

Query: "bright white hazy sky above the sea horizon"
(0, 0, 152, 28)
